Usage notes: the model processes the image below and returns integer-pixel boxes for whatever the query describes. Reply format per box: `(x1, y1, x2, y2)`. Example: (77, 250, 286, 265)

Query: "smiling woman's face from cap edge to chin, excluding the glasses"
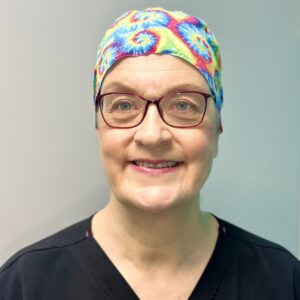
(97, 55, 219, 211)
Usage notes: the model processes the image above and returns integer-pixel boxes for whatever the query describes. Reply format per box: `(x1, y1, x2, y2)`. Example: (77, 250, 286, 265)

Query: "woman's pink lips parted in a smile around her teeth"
(129, 159, 182, 175)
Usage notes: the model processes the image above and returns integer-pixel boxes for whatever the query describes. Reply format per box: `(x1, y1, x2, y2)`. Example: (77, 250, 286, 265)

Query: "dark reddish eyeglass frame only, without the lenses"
(95, 91, 215, 129)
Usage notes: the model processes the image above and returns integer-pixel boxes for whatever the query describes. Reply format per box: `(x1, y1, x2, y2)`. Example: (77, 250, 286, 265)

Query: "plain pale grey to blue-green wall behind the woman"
(0, 0, 300, 263)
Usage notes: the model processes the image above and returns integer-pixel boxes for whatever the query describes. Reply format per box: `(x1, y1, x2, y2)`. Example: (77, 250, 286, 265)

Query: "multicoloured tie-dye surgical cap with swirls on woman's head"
(94, 8, 223, 111)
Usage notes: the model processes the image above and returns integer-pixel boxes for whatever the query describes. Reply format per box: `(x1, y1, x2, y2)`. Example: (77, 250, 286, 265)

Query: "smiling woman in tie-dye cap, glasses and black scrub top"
(0, 8, 300, 300)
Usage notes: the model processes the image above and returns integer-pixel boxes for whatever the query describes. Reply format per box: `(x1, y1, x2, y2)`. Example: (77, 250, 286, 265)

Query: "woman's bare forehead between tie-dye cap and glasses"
(102, 54, 210, 93)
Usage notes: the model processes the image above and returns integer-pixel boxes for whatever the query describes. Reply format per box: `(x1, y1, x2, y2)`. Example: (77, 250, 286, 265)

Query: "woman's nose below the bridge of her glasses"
(134, 103, 172, 148)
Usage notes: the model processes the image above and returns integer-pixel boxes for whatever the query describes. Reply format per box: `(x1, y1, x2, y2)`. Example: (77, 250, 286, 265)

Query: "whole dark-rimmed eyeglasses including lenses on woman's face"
(95, 91, 215, 128)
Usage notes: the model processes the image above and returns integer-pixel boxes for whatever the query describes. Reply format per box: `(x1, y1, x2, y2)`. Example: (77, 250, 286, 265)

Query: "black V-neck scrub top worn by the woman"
(0, 216, 300, 300)
